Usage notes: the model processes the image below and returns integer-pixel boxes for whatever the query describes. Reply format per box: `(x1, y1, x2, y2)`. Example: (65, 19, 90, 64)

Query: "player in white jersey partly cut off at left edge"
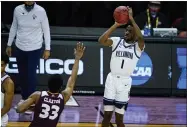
(1, 53, 14, 127)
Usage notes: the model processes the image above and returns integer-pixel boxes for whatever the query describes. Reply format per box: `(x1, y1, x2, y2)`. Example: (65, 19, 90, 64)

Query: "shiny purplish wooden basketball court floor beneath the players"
(8, 95, 187, 127)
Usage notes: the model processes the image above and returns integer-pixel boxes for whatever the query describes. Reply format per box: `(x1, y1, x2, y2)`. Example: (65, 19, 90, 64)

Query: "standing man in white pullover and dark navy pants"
(6, 1, 51, 114)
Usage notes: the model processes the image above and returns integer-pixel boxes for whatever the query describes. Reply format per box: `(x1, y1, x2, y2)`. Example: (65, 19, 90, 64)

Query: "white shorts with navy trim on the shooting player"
(103, 73, 132, 114)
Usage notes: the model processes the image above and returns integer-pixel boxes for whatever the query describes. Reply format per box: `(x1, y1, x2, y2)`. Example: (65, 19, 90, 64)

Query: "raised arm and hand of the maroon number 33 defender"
(62, 42, 85, 103)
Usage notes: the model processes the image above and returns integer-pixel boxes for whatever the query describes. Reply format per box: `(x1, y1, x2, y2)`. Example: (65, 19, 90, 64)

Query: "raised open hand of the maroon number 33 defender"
(74, 42, 85, 60)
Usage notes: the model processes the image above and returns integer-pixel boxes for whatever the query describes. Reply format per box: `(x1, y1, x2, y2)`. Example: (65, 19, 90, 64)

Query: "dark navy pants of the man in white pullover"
(15, 48, 41, 100)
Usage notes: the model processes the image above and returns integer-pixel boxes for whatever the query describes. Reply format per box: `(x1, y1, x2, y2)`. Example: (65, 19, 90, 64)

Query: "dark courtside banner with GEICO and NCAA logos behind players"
(6, 41, 186, 94)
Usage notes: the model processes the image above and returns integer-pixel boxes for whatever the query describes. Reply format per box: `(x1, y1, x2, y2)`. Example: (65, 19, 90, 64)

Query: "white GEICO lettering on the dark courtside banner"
(6, 57, 84, 75)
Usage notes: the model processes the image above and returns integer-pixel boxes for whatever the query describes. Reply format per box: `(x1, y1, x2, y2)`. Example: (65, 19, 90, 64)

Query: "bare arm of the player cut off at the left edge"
(1, 78, 14, 116)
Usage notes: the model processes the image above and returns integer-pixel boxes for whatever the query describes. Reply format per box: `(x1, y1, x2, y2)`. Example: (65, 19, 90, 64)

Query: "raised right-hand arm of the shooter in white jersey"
(128, 7, 145, 50)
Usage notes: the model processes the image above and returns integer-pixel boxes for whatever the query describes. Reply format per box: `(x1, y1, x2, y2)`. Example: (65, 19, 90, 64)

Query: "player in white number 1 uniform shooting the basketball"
(99, 7, 144, 127)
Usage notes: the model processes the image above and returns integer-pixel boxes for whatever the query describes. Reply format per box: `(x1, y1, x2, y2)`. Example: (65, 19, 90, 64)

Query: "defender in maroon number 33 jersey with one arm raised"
(16, 42, 85, 127)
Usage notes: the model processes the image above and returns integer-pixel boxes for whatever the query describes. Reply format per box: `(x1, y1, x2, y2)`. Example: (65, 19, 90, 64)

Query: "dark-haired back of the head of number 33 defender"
(48, 74, 63, 93)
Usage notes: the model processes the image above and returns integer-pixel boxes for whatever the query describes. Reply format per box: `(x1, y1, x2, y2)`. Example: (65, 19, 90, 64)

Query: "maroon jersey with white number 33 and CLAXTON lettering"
(29, 91, 64, 127)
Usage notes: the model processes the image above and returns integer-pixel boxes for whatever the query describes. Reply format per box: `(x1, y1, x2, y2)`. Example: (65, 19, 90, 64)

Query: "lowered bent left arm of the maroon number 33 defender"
(16, 91, 41, 113)
